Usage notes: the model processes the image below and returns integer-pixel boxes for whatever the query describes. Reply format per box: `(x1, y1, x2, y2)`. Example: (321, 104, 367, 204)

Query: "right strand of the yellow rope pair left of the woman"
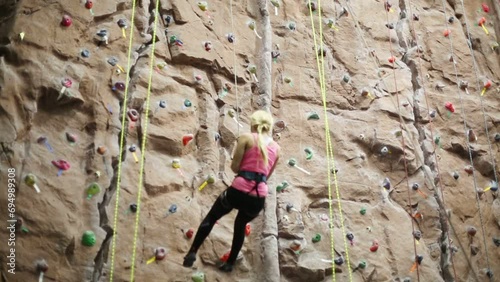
(130, 0, 160, 282)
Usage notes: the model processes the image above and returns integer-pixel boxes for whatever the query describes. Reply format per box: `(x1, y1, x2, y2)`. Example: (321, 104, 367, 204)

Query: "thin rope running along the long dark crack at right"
(408, 0, 457, 280)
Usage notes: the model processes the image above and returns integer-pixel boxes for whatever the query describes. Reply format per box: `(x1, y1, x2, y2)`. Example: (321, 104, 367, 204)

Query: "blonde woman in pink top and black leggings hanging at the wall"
(183, 111, 280, 272)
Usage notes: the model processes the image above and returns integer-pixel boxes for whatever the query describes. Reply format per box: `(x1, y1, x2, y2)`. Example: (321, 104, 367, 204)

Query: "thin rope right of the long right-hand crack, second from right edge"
(442, 0, 492, 279)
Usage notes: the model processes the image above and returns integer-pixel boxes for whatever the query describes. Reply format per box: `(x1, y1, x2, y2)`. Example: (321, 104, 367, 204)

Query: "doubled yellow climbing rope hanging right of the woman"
(308, 0, 353, 282)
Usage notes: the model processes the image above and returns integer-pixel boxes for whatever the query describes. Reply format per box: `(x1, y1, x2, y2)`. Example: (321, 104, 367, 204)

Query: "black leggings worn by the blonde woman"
(189, 187, 266, 264)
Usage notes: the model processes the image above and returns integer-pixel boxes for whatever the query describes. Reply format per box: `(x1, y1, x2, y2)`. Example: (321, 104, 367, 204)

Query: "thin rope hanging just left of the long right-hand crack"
(384, 3, 420, 282)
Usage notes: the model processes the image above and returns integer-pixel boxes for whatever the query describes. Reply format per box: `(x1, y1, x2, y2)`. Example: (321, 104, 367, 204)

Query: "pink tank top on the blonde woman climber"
(231, 133, 279, 197)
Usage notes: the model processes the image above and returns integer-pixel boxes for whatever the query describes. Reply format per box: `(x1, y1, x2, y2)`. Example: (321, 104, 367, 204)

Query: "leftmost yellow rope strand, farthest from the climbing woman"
(109, 1, 136, 282)
